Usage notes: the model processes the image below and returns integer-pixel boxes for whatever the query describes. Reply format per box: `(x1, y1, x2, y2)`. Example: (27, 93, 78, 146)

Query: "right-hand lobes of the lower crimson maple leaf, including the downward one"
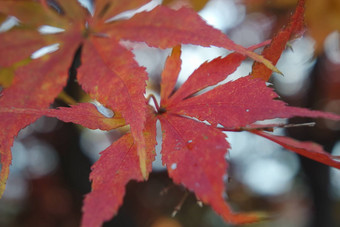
(152, 39, 340, 224)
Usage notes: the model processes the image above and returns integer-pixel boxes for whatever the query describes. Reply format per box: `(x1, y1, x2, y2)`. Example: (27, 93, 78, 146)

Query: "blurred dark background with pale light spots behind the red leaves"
(0, 0, 340, 227)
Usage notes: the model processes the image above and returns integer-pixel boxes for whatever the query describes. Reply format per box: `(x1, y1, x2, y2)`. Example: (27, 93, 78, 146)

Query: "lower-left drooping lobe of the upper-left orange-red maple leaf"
(0, 30, 79, 196)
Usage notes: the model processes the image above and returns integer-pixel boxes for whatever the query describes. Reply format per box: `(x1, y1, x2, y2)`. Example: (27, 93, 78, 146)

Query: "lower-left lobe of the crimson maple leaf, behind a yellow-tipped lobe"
(82, 108, 156, 227)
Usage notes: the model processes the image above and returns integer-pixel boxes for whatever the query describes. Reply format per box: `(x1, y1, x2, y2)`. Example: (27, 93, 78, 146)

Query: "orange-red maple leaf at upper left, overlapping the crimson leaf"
(0, 0, 275, 196)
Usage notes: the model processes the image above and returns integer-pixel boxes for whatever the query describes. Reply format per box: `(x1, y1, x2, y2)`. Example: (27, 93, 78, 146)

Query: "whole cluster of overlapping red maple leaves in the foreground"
(0, 0, 340, 227)
